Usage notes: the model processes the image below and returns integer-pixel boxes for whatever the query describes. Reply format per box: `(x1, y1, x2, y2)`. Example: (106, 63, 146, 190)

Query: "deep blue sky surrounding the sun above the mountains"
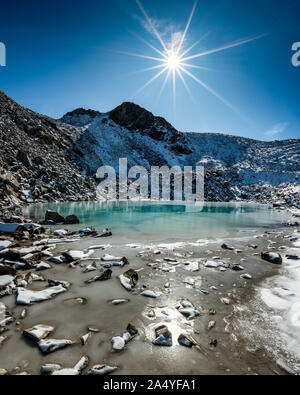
(0, 0, 300, 140)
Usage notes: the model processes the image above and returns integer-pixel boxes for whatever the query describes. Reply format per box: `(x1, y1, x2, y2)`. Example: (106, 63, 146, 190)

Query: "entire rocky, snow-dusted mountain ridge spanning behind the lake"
(0, 92, 300, 215)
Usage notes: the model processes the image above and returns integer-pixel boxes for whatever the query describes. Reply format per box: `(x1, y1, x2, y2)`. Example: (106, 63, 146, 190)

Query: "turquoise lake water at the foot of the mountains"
(25, 202, 285, 242)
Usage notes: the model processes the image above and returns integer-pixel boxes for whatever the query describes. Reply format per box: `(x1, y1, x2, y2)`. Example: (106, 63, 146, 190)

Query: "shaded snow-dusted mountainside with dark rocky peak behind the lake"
(61, 103, 300, 206)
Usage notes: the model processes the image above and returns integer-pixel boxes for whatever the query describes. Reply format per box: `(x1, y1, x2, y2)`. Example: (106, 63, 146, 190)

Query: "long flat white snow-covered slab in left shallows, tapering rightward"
(17, 285, 67, 305)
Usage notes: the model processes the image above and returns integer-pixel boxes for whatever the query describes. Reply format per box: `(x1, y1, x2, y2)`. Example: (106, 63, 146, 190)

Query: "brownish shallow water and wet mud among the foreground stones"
(0, 204, 298, 375)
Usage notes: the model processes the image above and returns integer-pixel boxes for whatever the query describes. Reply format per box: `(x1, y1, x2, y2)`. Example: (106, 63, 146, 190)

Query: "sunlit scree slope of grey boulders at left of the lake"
(0, 91, 95, 212)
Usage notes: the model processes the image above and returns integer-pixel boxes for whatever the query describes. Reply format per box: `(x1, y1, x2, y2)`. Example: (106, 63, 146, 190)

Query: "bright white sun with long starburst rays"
(118, 0, 264, 115)
